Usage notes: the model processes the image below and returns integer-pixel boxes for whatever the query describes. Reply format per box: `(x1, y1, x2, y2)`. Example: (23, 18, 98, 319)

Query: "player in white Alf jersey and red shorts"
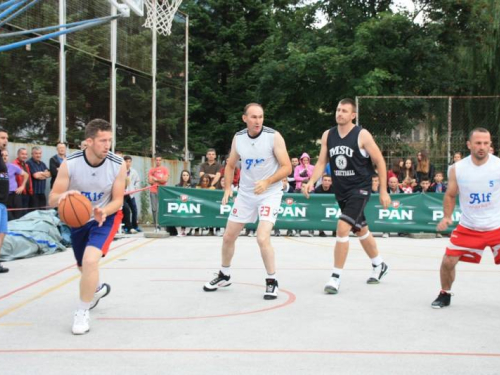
(431, 128, 500, 309)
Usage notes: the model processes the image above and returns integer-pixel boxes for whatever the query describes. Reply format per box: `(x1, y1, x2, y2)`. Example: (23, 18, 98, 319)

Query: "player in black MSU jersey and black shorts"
(302, 99, 391, 294)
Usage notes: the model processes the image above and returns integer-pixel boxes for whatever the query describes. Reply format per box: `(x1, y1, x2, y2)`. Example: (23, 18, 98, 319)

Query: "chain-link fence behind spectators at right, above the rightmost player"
(356, 96, 500, 179)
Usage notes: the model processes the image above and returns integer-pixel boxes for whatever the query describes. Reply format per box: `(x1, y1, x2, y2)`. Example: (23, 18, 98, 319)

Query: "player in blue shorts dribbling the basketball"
(49, 119, 126, 335)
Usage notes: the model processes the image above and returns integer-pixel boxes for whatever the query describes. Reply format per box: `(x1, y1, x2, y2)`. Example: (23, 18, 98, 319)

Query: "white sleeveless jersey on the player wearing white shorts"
(235, 126, 282, 197)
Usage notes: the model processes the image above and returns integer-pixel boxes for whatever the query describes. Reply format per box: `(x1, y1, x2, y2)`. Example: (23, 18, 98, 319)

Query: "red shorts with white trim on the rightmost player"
(446, 224, 500, 264)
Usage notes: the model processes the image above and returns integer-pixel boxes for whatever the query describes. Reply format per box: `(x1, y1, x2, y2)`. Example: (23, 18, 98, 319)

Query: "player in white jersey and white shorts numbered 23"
(203, 103, 292, 300)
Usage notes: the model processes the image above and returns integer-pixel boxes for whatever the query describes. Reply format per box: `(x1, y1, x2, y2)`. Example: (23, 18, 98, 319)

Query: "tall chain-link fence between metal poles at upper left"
(0, 0, 186, 159)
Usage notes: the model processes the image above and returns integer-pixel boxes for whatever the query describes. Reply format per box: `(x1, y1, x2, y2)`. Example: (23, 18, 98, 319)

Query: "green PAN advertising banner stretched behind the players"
(158, 187, 460, 233)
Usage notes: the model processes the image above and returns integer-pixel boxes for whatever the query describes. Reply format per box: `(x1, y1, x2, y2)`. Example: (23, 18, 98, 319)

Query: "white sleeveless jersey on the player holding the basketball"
(66, 151, 123, 217)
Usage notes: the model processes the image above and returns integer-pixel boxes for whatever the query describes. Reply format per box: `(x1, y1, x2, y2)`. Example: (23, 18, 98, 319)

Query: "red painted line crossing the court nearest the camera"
(0, 348, 500, 358)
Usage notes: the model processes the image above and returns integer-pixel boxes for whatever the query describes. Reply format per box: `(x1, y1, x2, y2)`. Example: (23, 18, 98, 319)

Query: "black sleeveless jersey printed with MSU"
(326, 126, 375, 199)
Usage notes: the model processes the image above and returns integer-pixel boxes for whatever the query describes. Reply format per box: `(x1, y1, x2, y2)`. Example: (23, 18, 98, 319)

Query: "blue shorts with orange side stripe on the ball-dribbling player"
(71, 211, 123, 267)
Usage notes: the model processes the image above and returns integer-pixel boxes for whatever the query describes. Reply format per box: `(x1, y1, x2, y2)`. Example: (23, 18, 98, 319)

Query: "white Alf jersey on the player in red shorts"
(454, 155, 500, 231)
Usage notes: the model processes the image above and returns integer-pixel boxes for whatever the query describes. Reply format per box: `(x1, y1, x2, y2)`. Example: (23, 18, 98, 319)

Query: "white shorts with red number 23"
(228, 192, 283, 224)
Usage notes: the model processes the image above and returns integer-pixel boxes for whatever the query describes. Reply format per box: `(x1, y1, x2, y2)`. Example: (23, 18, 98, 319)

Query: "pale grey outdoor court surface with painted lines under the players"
(0, 235, 500, 374)
